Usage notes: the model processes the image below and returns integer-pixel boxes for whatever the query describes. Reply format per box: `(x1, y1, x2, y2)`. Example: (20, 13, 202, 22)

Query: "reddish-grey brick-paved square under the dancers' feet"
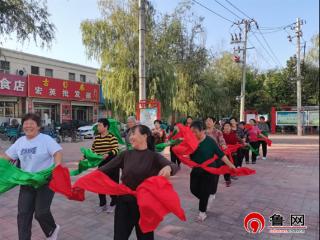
(0, 135, 319, 240)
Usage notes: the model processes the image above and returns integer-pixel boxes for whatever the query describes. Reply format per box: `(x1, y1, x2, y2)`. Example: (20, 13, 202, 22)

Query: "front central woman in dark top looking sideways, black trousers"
(100, 125, 178, 240)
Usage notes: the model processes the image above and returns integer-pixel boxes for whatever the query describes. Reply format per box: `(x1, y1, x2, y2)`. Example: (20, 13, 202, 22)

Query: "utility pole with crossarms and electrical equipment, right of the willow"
(231, 19, 257, 121)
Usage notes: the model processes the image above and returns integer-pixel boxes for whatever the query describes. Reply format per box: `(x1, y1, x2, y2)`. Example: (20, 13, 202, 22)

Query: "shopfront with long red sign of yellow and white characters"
(27, 75, 99, 125)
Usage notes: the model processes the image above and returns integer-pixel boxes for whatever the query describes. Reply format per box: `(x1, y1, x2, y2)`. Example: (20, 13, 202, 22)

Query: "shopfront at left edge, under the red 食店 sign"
(0, 73, 27, 122)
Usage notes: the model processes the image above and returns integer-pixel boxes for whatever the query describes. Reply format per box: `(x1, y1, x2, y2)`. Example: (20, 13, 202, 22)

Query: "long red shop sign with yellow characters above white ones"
(28, 75, 99, 102)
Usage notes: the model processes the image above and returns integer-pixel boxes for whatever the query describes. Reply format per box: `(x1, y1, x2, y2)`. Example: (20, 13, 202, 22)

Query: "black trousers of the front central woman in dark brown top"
(114, 195, 154, 240)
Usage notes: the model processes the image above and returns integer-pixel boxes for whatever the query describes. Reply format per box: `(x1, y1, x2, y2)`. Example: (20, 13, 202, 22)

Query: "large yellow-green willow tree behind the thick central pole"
(81, 0, 206, 116)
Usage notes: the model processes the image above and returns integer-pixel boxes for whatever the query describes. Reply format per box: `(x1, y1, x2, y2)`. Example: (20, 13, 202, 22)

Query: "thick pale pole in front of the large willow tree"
(139, 0, 146, 101)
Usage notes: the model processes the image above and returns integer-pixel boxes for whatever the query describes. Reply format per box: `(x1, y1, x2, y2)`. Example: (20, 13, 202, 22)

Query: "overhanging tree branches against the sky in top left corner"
(0, 0, 55, 47)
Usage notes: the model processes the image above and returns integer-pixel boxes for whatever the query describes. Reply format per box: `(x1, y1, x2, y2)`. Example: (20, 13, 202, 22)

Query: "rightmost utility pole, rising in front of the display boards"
(296, 18, 302, 136)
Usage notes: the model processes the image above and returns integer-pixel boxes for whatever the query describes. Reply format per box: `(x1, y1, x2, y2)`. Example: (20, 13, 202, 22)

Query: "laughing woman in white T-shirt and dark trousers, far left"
(0, 113, 62, 240)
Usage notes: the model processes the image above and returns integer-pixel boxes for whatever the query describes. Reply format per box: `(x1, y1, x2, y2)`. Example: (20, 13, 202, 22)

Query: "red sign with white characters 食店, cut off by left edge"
(0, 73, 27, 97)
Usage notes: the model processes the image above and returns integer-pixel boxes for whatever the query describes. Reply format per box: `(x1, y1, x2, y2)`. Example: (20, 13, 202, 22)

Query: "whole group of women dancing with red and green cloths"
(0, 113, 268, 240)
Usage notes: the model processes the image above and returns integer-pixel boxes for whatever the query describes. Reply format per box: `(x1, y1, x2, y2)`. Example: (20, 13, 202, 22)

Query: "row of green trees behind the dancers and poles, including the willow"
(81, 0, 319, 120)
